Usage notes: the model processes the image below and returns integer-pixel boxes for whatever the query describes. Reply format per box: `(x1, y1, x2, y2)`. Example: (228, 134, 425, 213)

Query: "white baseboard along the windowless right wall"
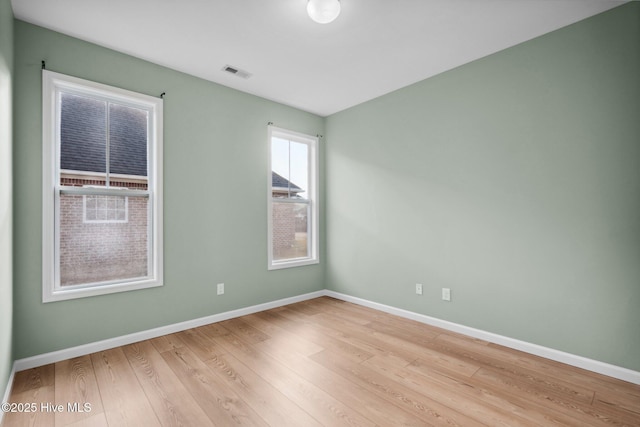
(324, 290, 640, 385)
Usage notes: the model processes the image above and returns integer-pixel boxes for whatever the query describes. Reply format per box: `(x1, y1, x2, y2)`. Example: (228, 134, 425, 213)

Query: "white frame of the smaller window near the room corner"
(267, 125, 320, 270)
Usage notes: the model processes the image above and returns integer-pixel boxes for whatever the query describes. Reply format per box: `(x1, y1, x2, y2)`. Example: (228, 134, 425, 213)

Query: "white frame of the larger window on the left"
(42, 70, 163, 303)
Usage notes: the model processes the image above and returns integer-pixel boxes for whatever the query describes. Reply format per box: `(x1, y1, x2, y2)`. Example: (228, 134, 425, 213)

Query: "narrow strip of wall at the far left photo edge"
(0, 0, 13, 398)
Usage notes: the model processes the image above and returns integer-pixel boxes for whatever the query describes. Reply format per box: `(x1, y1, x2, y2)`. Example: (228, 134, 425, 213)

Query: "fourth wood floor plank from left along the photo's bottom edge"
(123, 341, 215, 427)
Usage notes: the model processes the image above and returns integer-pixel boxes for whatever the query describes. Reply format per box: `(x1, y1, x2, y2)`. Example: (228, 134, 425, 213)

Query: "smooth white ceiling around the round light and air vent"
(12, 0, 625, 116)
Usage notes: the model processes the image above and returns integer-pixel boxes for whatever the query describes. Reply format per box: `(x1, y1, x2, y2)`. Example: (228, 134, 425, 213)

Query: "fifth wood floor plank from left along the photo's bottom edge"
(162, 346, 267, 426)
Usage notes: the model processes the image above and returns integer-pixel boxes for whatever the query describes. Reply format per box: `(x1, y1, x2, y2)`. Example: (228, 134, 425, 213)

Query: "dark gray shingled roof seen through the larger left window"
(60, 93, 148, 176)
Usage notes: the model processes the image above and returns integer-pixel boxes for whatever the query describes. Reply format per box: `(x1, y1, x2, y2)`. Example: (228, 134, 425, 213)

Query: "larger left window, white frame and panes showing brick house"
(43, 70, 162, 302)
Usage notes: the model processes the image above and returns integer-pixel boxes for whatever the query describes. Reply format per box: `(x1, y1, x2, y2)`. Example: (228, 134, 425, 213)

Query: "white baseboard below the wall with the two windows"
(14, 291, 325, 372)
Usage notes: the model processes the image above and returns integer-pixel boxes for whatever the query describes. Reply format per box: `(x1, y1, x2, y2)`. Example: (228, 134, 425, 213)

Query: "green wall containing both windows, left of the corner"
(13, 21, 324, 359)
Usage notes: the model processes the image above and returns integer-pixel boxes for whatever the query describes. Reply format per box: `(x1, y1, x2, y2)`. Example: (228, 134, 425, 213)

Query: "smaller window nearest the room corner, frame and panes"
(268, 126, 318, 269)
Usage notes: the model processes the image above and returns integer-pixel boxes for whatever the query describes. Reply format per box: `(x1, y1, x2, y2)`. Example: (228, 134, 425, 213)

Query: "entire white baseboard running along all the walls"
(11, 290, 640, 386)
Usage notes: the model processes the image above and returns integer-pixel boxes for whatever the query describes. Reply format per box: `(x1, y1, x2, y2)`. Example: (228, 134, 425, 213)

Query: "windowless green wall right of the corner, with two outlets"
(326, 2, 640, 370)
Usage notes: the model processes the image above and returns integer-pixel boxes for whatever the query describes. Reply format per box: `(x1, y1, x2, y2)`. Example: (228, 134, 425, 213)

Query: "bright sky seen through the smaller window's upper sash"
(271, 137, 309, 199)
